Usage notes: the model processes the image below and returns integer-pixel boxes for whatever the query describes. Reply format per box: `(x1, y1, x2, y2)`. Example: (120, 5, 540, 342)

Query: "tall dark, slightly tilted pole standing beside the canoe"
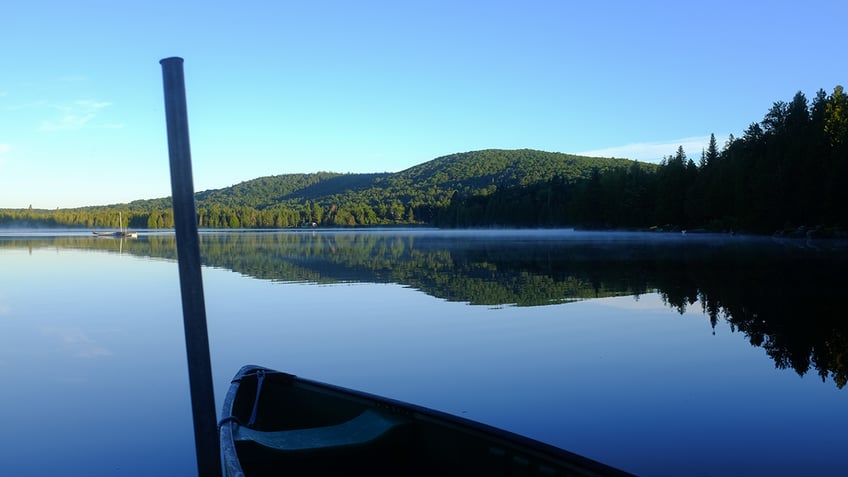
(159, 57, 221, 477)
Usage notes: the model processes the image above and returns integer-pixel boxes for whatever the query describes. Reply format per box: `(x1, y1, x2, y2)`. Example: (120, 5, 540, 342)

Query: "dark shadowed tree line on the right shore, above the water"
(437, 86, 848, 233)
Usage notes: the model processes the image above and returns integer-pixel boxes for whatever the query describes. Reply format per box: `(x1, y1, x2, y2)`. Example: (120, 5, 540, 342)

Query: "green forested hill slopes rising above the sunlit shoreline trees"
(127, 149, 636, 211)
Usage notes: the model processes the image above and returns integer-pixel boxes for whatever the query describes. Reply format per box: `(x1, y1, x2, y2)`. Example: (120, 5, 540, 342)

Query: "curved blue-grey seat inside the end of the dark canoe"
(233, 409, 406, 452)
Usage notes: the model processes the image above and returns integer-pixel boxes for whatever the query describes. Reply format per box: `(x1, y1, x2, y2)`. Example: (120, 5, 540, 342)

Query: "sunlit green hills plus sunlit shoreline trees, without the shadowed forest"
(0, 149, 640, 228)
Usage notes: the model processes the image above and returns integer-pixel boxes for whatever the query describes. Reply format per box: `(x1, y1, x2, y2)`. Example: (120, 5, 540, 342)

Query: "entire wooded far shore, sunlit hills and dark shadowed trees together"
(0, 86, 848, 234)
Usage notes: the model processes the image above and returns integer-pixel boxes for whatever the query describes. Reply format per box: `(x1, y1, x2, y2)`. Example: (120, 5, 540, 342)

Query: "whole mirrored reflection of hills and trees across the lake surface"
(0, 232, 848, 388)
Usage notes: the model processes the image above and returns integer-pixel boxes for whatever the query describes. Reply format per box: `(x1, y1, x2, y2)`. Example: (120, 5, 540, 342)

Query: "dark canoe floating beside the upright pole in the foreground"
(219, 366, 631, 477)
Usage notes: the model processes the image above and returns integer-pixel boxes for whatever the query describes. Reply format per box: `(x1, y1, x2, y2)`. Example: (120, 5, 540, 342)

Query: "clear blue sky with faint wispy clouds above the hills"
(0, 0, 848, 208)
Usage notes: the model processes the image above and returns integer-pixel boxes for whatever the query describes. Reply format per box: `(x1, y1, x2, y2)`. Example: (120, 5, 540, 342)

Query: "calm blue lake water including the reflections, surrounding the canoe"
(0, 230, 848, 476)
